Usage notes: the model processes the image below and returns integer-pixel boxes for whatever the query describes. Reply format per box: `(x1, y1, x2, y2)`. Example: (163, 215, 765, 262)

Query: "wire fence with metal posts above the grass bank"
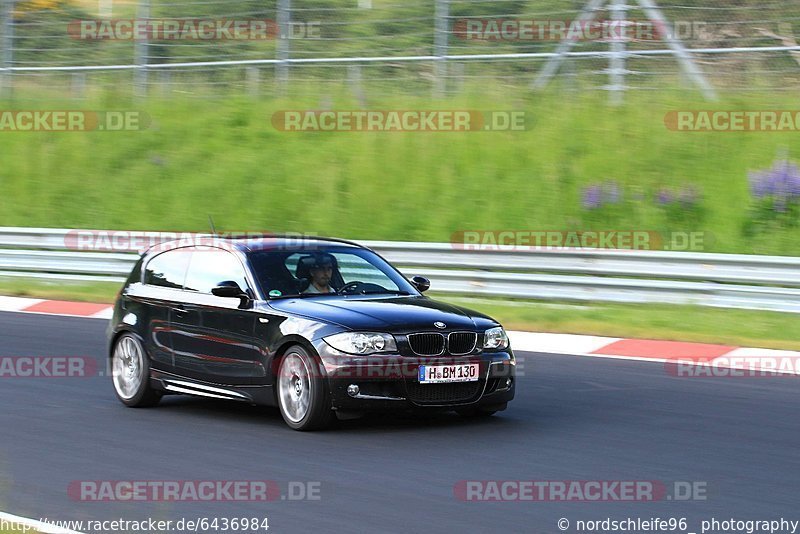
(0, 0, 800, 99)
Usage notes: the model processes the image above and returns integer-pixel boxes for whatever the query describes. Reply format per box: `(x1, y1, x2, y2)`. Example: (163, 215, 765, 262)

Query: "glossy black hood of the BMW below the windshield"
(269, 296, 497, 333)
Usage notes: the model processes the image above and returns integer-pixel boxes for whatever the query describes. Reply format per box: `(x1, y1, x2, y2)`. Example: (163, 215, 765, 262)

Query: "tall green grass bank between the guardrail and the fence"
(0, 83, 800, 255)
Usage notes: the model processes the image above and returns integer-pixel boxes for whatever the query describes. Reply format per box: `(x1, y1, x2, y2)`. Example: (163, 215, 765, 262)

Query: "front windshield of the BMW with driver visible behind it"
(248, 245, 418, 299)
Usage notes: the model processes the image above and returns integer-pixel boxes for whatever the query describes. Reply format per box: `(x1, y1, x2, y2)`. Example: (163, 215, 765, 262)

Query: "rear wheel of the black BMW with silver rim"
(111, 334, 161, 408)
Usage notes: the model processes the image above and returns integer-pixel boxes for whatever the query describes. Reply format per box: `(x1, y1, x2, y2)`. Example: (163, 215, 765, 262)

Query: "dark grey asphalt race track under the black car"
(0, 313, 800, 533)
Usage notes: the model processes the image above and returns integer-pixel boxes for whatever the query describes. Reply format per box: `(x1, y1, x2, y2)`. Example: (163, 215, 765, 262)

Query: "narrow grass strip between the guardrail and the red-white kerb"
(0, 277, 800, 350)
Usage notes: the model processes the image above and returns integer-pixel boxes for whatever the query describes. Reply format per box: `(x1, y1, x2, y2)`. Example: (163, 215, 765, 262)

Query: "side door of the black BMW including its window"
(171, 247, 260, 386)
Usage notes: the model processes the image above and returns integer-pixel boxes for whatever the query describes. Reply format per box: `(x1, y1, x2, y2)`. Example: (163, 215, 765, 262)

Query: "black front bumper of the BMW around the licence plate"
(314, 340, 516, 412)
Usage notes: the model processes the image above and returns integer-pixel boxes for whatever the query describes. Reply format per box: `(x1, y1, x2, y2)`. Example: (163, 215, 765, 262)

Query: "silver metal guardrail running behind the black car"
(0, 227, 800, 313)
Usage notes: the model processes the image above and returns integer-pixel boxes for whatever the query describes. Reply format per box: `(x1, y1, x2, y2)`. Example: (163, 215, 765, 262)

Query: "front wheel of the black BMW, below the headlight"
(276, 345, 334, 430)
